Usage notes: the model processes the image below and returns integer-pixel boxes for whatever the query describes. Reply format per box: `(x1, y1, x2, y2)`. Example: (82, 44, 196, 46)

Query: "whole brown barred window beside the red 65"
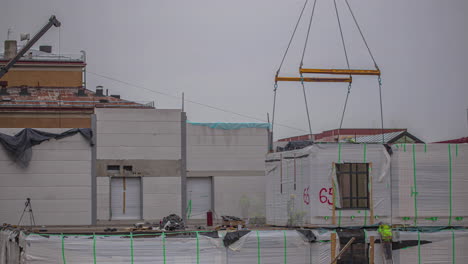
(336, 163, 369, 209)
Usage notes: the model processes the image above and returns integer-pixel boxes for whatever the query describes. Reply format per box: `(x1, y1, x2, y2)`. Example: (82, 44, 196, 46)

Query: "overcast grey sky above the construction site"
(0, 0, 468, 141)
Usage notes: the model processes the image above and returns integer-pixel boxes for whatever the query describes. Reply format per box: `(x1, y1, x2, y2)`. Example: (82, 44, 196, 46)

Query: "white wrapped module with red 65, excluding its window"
(266, 144, 391, 227)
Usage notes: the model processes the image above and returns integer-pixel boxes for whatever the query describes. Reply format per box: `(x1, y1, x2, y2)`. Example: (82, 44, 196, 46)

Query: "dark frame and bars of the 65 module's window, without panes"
(335, 162, 370, 210)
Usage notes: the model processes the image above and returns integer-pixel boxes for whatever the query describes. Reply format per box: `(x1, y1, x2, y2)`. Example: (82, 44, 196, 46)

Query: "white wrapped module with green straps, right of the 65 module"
(392, 144, 468, 226)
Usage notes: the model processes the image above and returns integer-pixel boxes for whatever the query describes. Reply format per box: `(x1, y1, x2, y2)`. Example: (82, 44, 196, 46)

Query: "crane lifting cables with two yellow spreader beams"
(272, 0, 384, 143)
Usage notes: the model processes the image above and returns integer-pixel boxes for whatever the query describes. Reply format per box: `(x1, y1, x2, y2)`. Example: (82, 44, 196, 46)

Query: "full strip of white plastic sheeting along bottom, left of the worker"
(0, 230, 338, 264)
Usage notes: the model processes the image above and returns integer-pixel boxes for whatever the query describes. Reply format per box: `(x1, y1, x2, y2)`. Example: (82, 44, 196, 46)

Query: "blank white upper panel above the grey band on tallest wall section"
(96, 109, 181, 160)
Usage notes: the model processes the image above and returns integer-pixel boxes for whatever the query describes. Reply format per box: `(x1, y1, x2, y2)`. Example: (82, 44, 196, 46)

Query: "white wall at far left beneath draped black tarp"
(0, 128, 91, 225)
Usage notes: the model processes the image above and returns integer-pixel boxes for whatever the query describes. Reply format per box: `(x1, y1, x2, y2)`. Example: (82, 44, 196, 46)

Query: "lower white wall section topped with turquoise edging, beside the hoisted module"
(187, 124, 268, 218)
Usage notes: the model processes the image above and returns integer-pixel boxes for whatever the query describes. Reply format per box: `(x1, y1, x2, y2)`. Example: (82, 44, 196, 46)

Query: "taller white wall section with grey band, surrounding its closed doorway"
(96, 109, 181, 220)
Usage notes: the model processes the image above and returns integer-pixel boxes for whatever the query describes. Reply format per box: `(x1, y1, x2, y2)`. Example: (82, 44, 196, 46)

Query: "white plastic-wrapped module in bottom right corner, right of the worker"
(392, 230, 468, 264)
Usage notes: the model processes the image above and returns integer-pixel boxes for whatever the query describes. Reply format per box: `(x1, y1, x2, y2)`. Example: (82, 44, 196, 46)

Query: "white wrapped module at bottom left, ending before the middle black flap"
(20, 232, 226, 264)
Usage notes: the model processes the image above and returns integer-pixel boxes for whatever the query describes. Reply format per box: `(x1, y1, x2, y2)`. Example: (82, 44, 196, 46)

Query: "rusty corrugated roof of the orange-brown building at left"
(0, 87, 154, 109)
